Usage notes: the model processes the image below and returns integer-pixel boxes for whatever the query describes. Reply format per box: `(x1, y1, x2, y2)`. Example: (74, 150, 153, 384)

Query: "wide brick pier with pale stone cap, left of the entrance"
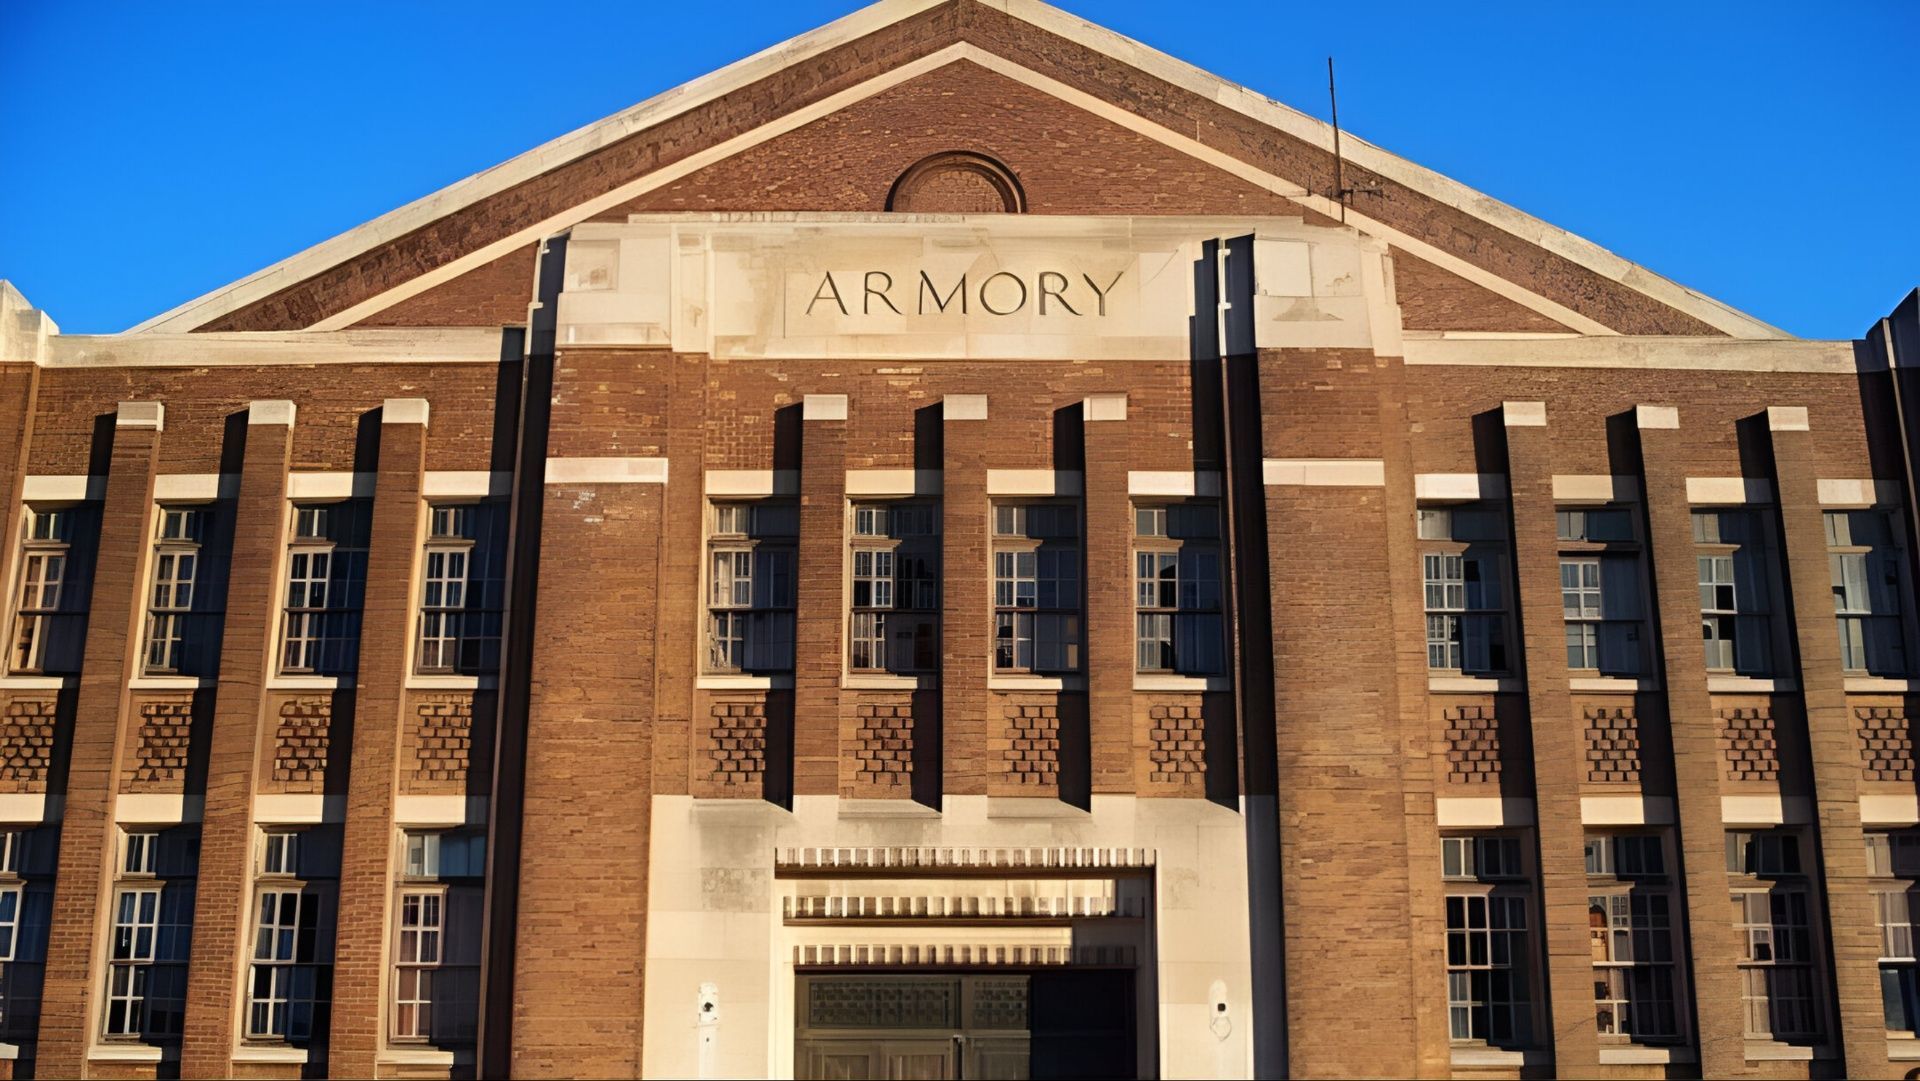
(513, 459, 664, 1077)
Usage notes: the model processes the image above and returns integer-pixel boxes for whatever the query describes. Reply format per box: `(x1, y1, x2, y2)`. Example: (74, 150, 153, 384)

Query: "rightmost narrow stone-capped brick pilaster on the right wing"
(1766, 407, 1901, 1077)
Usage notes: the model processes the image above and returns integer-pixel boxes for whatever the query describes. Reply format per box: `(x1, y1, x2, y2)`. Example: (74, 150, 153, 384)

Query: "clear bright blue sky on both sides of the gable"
(0, 0, 1920, 338)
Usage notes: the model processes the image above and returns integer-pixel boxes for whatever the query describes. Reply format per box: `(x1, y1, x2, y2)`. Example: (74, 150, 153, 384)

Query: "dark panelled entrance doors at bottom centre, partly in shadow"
(793, 970, 1135, 1081)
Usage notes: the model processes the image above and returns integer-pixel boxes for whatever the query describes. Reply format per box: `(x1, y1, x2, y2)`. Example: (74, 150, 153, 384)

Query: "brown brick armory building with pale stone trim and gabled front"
(0, 0, 1920, 1079)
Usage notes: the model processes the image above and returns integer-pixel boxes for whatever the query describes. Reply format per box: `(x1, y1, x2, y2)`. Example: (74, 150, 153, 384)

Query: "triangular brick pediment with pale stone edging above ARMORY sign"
(136, 0, 1786, 338)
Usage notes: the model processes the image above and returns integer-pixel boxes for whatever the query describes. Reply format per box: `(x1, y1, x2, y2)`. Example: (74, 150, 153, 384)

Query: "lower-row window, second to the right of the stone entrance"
(1586, 833, 1680, 1043)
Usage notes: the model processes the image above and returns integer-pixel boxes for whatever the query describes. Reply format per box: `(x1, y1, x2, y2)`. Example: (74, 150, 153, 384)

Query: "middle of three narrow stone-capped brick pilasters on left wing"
(180, 401, 294, 1077)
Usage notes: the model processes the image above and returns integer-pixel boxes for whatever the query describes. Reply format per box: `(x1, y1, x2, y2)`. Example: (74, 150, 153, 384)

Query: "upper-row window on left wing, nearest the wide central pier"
(415, 503, 507, 676)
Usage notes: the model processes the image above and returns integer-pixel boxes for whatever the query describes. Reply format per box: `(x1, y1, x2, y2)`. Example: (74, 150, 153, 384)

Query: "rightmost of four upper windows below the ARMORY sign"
(1133, 503, 1227, 676)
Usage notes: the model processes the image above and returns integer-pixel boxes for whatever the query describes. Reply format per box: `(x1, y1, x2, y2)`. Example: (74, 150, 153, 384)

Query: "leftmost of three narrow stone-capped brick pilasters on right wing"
(1501, 401, 1599, 1077)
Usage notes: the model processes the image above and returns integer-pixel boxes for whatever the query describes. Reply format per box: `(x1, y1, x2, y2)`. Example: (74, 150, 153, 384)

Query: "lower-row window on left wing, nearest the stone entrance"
(388, 829, 486, 1046)
